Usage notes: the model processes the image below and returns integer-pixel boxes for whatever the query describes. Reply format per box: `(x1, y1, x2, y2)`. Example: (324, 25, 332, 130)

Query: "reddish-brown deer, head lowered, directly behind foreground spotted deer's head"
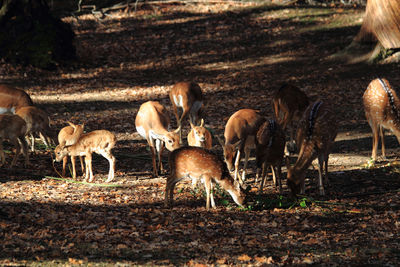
(218, 109, 265, 183)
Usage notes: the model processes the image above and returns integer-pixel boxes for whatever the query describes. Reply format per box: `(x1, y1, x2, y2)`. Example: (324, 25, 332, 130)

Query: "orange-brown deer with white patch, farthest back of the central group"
(169, 82, 203, 143)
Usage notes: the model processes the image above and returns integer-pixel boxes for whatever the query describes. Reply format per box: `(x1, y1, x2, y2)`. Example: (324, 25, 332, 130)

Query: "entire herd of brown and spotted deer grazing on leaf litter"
(0, 79, 400, 209)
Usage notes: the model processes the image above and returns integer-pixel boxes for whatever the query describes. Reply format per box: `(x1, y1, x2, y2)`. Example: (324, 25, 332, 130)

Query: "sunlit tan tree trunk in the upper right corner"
(354, 0, 400, 49)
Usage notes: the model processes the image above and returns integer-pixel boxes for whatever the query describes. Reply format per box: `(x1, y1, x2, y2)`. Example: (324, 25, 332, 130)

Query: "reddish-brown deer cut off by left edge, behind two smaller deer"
(0, 84, 33, 114)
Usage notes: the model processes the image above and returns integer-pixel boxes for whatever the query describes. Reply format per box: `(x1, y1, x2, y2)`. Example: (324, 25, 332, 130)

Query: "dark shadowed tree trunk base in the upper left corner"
(0, 0, 75, 68)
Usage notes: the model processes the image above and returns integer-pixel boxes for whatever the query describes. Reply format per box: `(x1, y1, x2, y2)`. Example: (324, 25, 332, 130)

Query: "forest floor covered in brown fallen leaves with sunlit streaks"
(0, 1, 400, 266)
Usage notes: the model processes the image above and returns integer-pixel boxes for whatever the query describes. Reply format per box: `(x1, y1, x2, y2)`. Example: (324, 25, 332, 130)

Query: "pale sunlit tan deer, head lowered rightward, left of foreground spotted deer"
(135, 101, 180, 177)
